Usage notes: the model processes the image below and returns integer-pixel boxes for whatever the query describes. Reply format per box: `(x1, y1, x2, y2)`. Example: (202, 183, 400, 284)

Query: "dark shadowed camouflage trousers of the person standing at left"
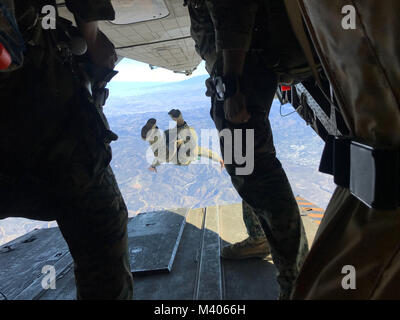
(0, 41, 133, 299)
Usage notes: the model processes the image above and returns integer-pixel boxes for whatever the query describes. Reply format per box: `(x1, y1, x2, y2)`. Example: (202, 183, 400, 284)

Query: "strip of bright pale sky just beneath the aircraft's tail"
(113, 58, 207, 82)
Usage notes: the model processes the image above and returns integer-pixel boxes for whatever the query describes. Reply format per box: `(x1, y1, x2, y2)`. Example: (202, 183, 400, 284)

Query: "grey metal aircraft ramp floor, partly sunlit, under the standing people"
(0, 198, 322, 300)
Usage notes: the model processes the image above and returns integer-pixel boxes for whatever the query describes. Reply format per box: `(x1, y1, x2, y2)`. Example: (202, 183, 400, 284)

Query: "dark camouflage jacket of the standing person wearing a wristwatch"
(186, 0, 259, 72)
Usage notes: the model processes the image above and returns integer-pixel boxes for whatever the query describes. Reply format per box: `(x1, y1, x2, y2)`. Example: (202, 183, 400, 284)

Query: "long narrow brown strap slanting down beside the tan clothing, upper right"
(284, 0, 323, 88)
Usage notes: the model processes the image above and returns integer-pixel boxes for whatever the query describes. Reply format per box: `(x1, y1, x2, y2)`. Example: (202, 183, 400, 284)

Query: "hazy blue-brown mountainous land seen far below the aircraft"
(0, 60, 334, 245)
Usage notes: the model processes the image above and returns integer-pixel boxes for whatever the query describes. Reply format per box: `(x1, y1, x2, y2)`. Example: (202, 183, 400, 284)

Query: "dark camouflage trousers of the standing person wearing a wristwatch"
(211, 55, 308, 298)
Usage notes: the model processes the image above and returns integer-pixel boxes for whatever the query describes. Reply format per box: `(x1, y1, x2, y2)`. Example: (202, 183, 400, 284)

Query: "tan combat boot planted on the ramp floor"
(221, 237, 271, 260)
